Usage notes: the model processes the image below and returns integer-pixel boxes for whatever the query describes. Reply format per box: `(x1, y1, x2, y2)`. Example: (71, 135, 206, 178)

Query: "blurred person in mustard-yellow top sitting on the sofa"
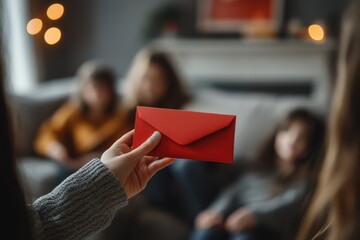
(35, 60, 132, 173)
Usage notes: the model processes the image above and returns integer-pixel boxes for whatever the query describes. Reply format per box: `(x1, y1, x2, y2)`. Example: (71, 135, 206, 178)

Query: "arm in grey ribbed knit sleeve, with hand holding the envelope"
(31, 131, 173, 240)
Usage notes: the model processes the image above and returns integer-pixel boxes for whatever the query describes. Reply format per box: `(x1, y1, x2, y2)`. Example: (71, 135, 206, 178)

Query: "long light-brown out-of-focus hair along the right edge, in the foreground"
(298, 0, 360, 240)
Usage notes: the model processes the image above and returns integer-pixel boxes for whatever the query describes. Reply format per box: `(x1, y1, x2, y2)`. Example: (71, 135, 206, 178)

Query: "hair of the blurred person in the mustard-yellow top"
(76, 60, 119, 115)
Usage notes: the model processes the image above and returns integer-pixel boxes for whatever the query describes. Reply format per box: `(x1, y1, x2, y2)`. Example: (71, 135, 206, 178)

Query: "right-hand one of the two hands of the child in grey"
(225, 208, 256, 234)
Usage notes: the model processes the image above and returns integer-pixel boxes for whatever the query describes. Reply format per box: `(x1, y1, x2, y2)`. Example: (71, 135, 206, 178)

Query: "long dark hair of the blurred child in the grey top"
(252, 107, 325, 192)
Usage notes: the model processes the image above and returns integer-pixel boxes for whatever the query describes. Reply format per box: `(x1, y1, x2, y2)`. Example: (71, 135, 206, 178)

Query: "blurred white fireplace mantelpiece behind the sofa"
(150, 39, 335, 107)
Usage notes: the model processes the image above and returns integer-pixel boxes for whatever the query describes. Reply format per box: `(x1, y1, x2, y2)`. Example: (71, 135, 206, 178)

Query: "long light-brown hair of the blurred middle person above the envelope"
(124, 48, 190, 109)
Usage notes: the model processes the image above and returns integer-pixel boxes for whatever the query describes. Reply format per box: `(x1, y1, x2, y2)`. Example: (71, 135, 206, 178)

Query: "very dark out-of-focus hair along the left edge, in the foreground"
(0, 15, 33, 240)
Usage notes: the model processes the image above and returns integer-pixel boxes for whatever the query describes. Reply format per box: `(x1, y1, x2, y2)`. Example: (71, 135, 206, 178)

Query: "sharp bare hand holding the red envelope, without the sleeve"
(101, 130, 174, 198)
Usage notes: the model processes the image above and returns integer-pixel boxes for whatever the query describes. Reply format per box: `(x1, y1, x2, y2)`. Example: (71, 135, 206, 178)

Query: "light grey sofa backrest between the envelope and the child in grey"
(185, 89, 326, 161)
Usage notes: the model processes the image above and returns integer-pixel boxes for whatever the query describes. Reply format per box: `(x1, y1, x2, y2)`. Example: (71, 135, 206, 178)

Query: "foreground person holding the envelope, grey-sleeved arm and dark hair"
(0, 26, 173, 240)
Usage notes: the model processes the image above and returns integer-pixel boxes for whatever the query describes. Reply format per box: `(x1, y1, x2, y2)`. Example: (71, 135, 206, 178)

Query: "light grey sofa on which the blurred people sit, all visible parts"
(10, 77, 328, 240)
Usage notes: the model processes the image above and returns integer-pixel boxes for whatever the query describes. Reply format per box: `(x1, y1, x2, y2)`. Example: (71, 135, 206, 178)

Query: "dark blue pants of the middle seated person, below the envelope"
(144, 159, 237, 224)
